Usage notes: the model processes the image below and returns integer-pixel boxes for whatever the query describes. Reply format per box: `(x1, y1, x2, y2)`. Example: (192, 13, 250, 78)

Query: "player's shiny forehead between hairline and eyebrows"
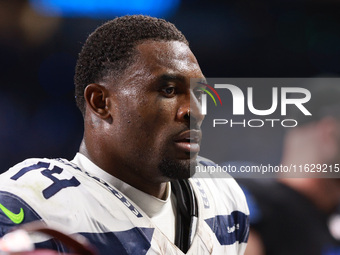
(135, 41, 203, 78)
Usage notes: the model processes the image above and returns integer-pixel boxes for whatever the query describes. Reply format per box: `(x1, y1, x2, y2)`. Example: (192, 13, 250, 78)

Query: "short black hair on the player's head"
(74, 15, 188, 115)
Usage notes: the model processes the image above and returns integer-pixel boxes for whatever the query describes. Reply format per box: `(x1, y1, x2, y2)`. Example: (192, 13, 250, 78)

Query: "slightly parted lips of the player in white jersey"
(174, 130, 202, 153)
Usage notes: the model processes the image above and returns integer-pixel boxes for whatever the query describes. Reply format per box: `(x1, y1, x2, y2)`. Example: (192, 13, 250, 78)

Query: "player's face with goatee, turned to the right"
(106, 41, 204, 182)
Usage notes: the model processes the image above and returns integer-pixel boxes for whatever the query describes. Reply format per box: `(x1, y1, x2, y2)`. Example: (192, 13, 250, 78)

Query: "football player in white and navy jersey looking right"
(0, 15, 249, 255)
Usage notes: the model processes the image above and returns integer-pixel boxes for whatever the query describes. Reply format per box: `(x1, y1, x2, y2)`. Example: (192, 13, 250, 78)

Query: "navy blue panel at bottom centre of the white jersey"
(80, 227, 154, 255)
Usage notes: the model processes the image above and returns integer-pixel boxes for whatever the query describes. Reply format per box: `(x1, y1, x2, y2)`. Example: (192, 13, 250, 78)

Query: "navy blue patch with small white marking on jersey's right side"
(205, 211, 249, 245)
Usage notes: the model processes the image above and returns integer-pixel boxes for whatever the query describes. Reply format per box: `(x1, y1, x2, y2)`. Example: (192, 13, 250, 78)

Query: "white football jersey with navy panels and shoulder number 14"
(0, 154, 249, 255)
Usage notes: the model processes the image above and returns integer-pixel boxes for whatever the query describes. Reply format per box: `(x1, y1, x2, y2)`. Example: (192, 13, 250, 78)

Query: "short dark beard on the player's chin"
(158, 157, 197, 180)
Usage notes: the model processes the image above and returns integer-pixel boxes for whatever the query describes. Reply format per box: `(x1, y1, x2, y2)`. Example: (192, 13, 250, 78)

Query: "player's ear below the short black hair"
(84, 83, 110, 119)
